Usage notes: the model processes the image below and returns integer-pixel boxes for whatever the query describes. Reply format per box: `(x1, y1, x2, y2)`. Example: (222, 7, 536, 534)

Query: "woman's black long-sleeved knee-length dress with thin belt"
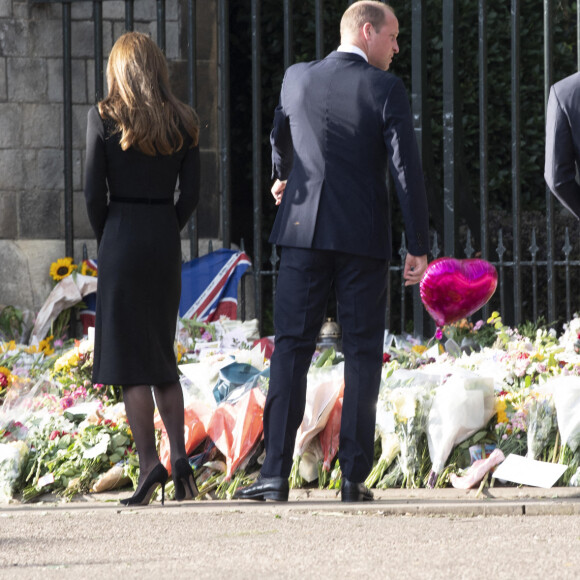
(85, 107, 199, 385)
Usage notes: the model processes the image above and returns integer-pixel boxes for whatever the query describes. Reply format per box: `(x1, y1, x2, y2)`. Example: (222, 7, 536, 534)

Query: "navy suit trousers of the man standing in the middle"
(262, 247, 388, 482)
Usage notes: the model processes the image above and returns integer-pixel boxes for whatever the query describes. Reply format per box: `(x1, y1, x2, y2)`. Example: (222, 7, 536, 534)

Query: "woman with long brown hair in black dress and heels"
(85, 32, 200, 505)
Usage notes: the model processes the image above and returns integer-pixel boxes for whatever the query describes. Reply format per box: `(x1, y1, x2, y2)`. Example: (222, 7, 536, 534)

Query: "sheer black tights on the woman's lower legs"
(123, 381, 187, 490)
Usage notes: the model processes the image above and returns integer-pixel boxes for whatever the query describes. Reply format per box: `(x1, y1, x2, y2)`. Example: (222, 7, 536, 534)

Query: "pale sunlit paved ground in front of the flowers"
(0, 487, 580, 580)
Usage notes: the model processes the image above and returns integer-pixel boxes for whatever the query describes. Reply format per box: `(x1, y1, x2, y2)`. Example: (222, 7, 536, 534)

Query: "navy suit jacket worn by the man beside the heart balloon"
(270, 52, 429, 259)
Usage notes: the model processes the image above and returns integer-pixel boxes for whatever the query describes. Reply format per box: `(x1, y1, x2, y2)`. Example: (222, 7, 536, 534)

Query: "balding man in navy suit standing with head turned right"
(236, 1, 428, 501)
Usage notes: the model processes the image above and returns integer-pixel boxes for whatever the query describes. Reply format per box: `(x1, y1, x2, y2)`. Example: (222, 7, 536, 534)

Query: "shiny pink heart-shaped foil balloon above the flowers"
(420, 258, 497, 326)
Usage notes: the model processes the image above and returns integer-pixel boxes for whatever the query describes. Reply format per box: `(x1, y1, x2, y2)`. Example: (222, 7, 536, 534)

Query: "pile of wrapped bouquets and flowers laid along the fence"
(0, 313, 580, 502)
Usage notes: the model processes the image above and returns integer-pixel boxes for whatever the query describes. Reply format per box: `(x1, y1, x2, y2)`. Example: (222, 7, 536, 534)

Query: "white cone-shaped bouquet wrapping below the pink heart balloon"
(427, 369, 495, 474)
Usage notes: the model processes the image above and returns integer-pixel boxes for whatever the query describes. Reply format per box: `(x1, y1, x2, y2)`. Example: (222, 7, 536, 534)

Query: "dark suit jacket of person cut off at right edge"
(544, 73, 580, 219)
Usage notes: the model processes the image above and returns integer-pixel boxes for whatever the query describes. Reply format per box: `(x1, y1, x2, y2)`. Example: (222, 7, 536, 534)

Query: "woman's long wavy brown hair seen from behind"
(98, 32, 199, 155)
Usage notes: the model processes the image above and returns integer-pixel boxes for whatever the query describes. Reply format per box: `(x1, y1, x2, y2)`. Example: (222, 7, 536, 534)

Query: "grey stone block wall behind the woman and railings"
(0, 0, 219, 311)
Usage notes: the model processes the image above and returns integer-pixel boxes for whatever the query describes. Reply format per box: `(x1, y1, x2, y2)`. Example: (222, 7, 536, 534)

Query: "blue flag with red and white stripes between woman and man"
(179, 248, 252, 322)
